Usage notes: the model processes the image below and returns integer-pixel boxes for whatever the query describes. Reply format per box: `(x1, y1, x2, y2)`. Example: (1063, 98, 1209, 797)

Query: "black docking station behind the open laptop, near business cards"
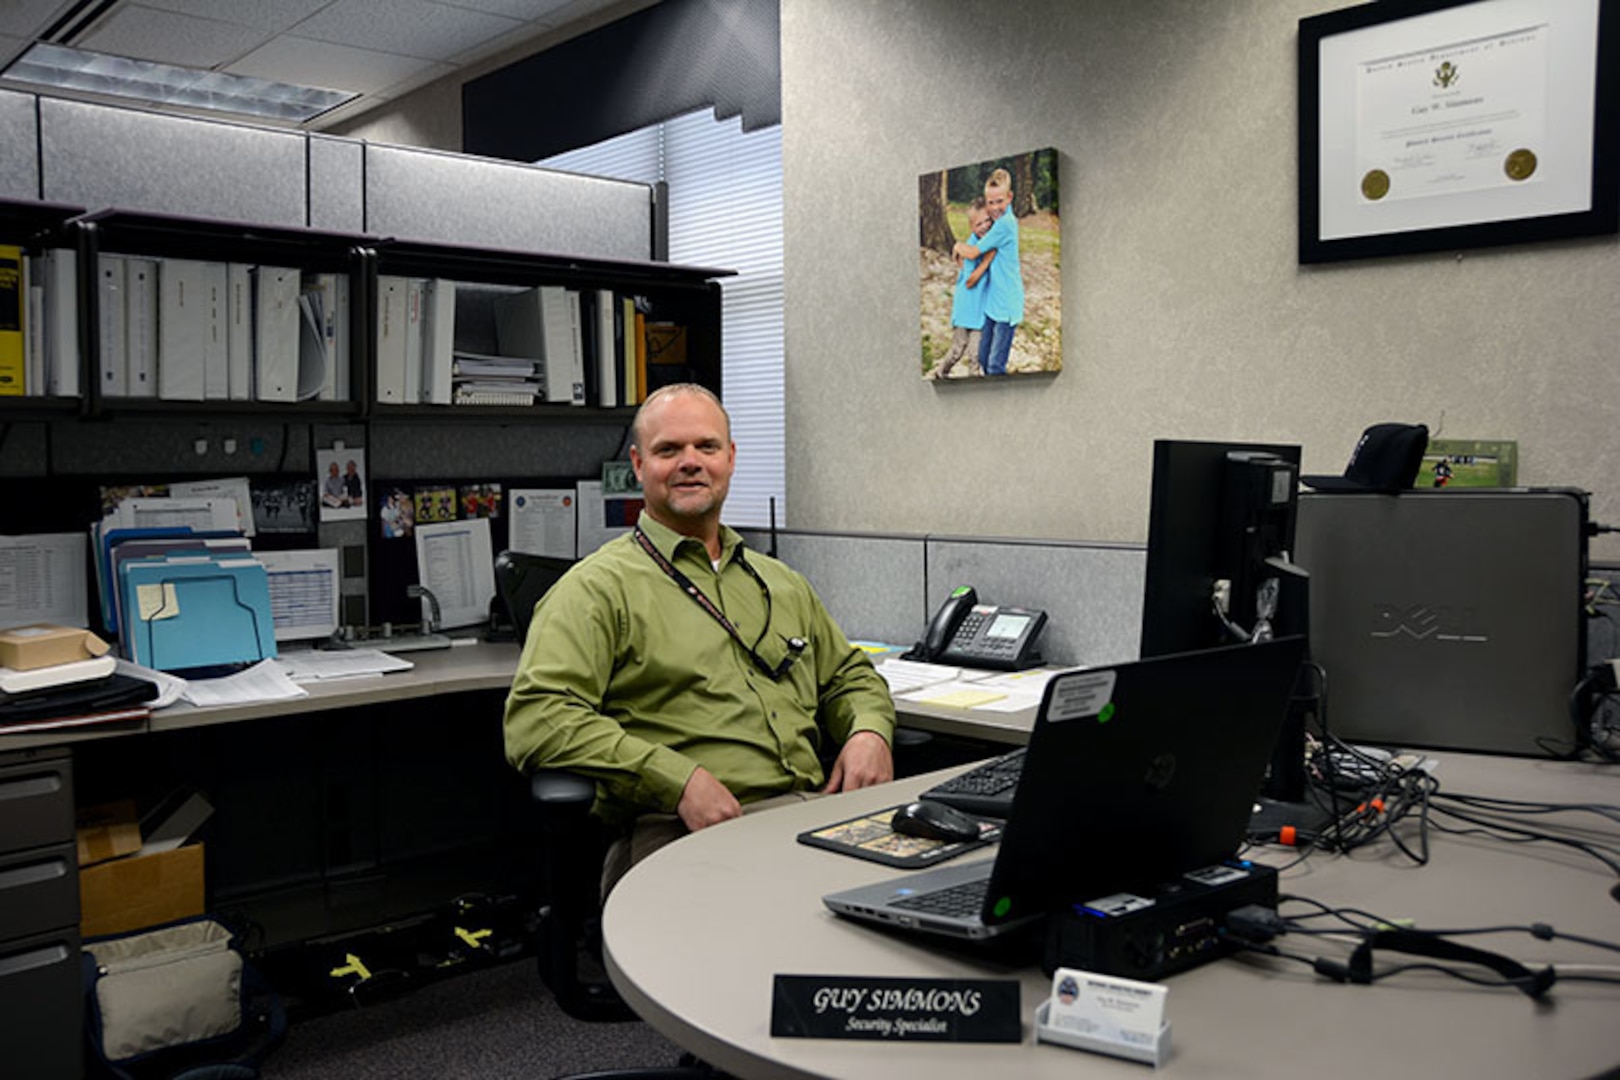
(1042, 860, 1277, 983)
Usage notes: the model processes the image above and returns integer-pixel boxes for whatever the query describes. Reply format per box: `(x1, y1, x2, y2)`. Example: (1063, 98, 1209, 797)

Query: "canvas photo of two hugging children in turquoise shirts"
(917, 149, 1063, 381)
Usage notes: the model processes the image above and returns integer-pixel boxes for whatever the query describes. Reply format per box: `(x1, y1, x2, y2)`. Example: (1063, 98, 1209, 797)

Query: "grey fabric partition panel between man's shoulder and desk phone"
(744, 529, 925, 644)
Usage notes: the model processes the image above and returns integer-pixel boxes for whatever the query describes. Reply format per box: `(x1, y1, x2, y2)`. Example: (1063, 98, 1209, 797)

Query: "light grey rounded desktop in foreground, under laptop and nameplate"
(604, 755, 1620, 1080)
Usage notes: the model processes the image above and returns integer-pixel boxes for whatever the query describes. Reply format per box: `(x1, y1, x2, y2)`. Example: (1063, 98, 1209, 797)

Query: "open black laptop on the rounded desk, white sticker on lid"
(821, 638, 1304, 941)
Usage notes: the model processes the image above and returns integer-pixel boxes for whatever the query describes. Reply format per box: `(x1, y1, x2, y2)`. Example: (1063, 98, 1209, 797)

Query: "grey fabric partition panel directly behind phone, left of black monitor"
(928, 539, 1147, 664)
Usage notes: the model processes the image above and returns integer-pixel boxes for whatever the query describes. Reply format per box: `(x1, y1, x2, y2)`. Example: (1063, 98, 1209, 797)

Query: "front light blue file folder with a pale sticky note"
(120, 555, 275, 672)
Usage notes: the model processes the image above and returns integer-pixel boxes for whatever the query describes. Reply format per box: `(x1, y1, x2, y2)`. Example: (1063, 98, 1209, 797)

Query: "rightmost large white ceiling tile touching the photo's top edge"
(286, 0, 518, 60)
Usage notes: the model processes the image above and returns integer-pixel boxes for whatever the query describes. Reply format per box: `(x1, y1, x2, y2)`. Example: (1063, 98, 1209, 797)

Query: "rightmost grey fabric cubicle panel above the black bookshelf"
(366, 144, 653, 259)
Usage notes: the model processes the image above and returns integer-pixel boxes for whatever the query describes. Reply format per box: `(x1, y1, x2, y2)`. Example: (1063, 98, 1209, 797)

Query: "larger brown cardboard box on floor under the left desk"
(79, 844, 203, 938)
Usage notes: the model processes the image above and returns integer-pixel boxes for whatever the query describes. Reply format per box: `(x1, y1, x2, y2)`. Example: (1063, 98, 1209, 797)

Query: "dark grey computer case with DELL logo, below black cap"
(1294, 489, 1588, 755)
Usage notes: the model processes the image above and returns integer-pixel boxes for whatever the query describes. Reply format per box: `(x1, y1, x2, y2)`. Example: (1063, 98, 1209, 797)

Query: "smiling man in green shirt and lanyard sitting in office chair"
(505, 384, 894, 899)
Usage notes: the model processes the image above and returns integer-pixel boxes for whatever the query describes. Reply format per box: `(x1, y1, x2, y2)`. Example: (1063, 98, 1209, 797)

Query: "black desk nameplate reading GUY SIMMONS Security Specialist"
(771, 975, 1024, 1043)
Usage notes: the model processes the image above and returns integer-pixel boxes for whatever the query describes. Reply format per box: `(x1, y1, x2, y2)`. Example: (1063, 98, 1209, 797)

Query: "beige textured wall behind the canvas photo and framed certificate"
(781, 0, 1620, 559)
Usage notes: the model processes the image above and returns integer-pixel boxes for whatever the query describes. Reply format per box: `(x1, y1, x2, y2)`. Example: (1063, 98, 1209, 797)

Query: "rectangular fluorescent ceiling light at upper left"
(0, 42, 360, 123)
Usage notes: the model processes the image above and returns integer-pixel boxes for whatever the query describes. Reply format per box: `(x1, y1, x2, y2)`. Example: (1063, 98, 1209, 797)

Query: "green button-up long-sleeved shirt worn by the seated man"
(505, 513, 894, 823)
